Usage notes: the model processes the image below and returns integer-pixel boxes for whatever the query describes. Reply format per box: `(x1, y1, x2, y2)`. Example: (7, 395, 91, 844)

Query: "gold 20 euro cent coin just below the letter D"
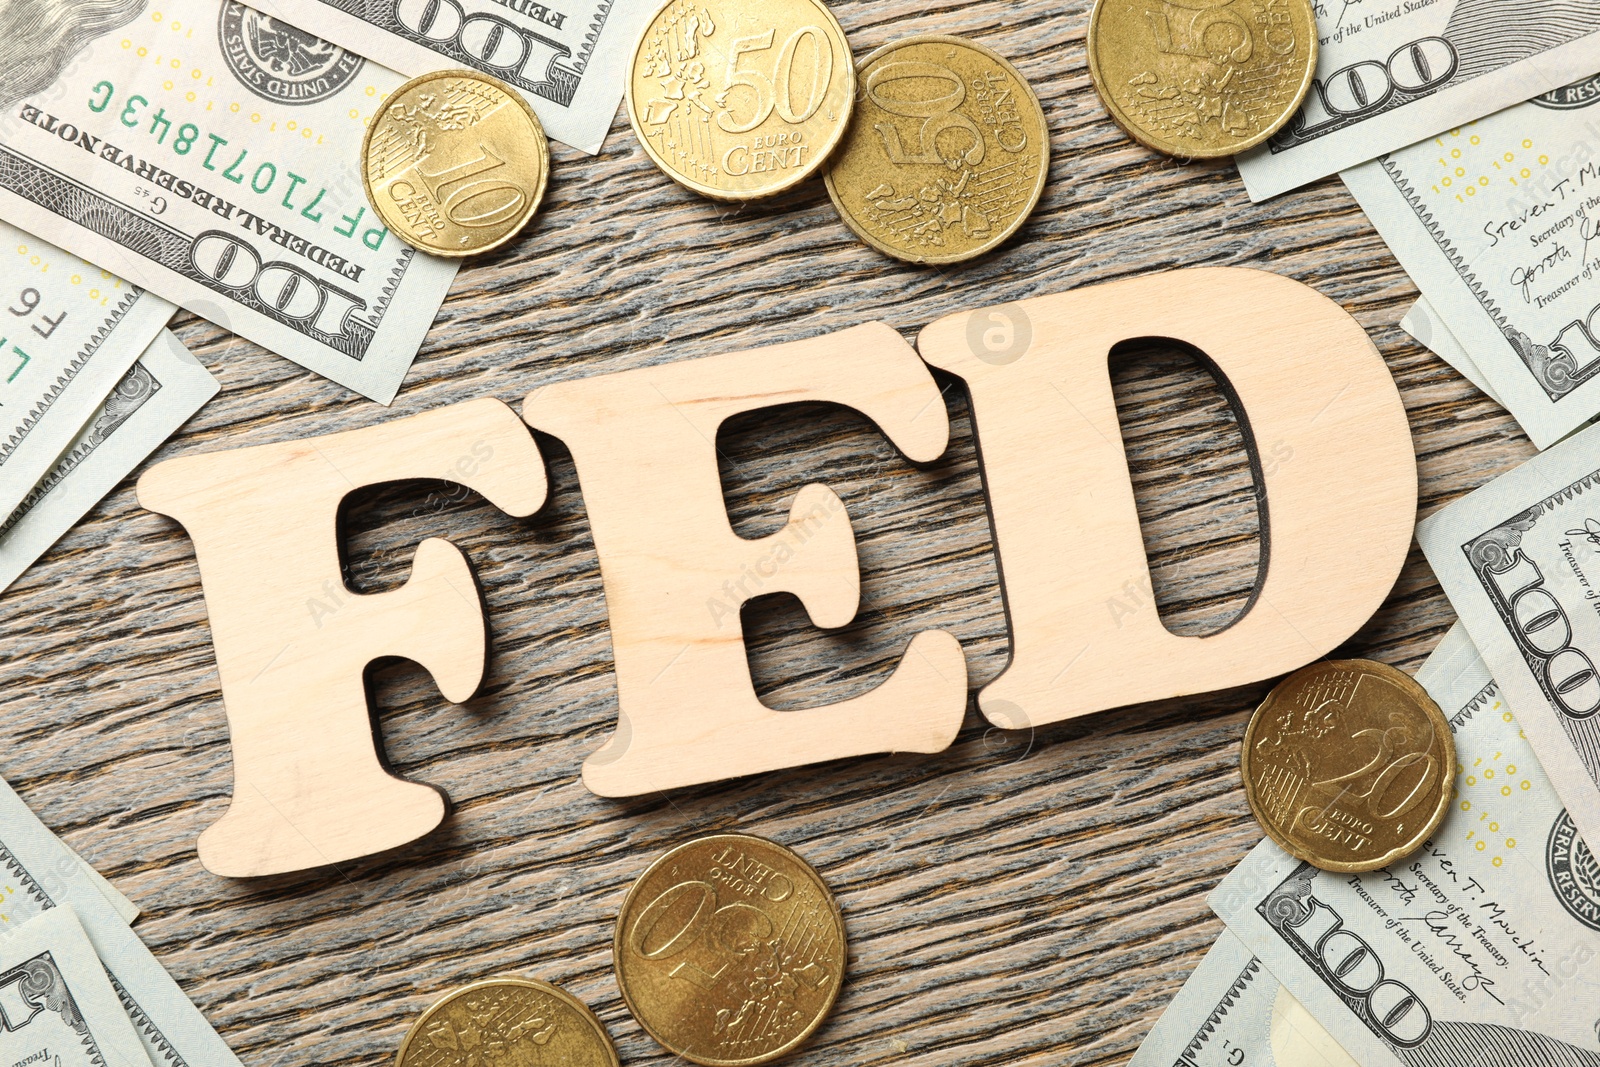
(1238, 659, 1456, 873)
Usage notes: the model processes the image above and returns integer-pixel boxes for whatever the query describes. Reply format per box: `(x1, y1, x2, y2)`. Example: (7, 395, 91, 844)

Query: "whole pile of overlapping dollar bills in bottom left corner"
(0, 781, 240, 1067)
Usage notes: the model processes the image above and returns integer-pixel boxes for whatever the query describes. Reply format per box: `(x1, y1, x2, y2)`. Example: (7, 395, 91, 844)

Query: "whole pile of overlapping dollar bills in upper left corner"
(0, 0, 658, 590)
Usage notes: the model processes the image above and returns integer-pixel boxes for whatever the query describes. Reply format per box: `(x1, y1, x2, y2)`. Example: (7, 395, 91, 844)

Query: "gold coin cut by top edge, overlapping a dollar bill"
(1088, 0, 1317, 160)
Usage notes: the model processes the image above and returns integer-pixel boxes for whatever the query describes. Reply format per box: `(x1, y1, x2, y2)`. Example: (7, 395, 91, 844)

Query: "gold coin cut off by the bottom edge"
(395, 977, 619, 1067)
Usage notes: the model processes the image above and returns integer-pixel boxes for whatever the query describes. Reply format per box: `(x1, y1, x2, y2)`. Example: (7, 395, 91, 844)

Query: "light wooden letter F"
(139, 398, 546, 877)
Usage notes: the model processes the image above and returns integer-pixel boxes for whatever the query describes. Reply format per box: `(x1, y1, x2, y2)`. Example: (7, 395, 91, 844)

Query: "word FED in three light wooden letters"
(139, 267, 1416, 877)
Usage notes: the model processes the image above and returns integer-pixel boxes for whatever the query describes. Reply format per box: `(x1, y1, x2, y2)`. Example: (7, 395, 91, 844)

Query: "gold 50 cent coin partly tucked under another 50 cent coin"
(827, 34, 1050, 264)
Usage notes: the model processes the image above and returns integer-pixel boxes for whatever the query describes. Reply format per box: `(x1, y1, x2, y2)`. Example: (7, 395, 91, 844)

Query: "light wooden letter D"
(917, 267, 1416, 728)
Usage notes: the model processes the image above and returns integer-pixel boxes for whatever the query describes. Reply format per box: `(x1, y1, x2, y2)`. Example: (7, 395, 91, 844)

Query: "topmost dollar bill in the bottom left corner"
(0, 905, 150, 1067)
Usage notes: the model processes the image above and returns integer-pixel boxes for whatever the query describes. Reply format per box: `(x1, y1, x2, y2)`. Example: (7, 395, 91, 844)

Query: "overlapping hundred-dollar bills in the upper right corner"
(1238, 0, 1600, 448)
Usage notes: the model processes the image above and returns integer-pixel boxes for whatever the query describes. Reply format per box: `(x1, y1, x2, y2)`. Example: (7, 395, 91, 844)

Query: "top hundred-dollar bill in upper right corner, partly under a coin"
(1235, 0, 1600, 200)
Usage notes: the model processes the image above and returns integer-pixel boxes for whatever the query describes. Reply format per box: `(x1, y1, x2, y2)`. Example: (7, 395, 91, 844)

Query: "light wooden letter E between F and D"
(523, 323, 966, 797)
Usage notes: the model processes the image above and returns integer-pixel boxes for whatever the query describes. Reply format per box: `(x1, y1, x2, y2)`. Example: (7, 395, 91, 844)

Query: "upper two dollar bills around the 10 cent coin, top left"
(0, 0, 658, 403)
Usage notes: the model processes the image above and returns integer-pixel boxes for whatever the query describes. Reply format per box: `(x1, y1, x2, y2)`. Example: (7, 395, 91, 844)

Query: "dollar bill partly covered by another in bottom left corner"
(0, 781, 242, 1067)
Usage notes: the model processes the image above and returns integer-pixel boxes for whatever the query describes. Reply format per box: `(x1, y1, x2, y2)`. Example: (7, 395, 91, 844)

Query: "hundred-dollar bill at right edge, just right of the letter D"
(1416, 427, 1600, 843)
